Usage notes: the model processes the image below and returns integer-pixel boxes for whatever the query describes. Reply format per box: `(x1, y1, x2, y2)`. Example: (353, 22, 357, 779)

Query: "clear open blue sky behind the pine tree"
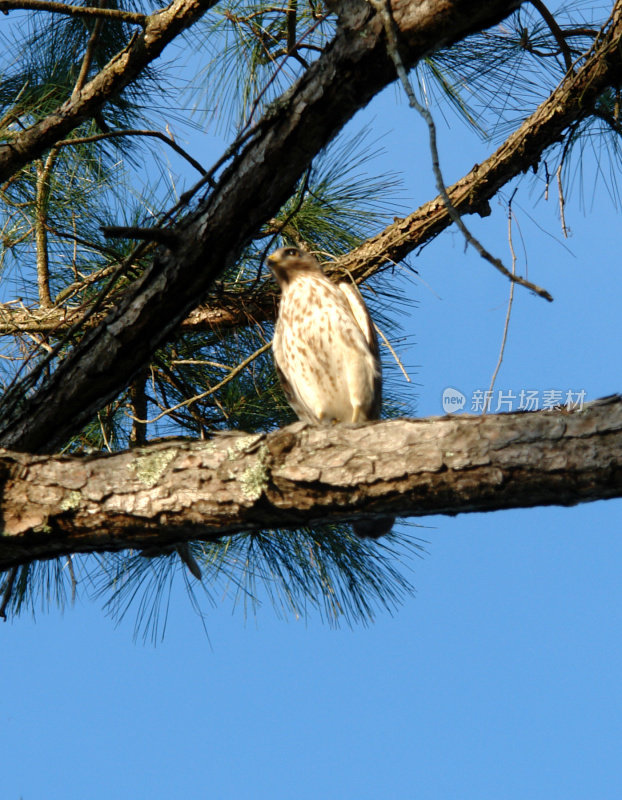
(0, 12, 622, 800)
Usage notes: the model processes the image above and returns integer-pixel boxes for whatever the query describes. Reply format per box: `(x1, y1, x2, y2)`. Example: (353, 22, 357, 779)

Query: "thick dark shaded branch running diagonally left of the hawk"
(0, 0, 519, 451)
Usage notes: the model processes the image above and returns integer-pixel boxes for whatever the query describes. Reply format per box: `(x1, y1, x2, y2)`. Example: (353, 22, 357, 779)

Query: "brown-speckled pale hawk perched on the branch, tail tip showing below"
(268, 247, 395, 538)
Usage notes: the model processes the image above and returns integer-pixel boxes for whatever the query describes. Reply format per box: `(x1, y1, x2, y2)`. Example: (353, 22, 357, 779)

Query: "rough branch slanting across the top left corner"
(0, 0, 216, 183)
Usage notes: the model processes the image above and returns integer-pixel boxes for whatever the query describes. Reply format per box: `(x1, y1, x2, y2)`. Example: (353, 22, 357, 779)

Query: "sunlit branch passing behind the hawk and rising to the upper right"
(0, 3, 622, 335)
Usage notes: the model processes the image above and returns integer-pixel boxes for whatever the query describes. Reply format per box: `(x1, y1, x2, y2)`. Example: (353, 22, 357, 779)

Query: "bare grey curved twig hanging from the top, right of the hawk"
(369, 0, 553, 302)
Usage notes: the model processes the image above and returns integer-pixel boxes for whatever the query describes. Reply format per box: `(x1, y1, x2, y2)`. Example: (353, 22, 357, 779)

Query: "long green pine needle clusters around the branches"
(0, 0, 622, 638)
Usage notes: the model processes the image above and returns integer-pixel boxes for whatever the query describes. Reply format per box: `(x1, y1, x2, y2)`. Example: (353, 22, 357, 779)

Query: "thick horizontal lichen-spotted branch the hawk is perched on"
(0, 396, 622, 570)
